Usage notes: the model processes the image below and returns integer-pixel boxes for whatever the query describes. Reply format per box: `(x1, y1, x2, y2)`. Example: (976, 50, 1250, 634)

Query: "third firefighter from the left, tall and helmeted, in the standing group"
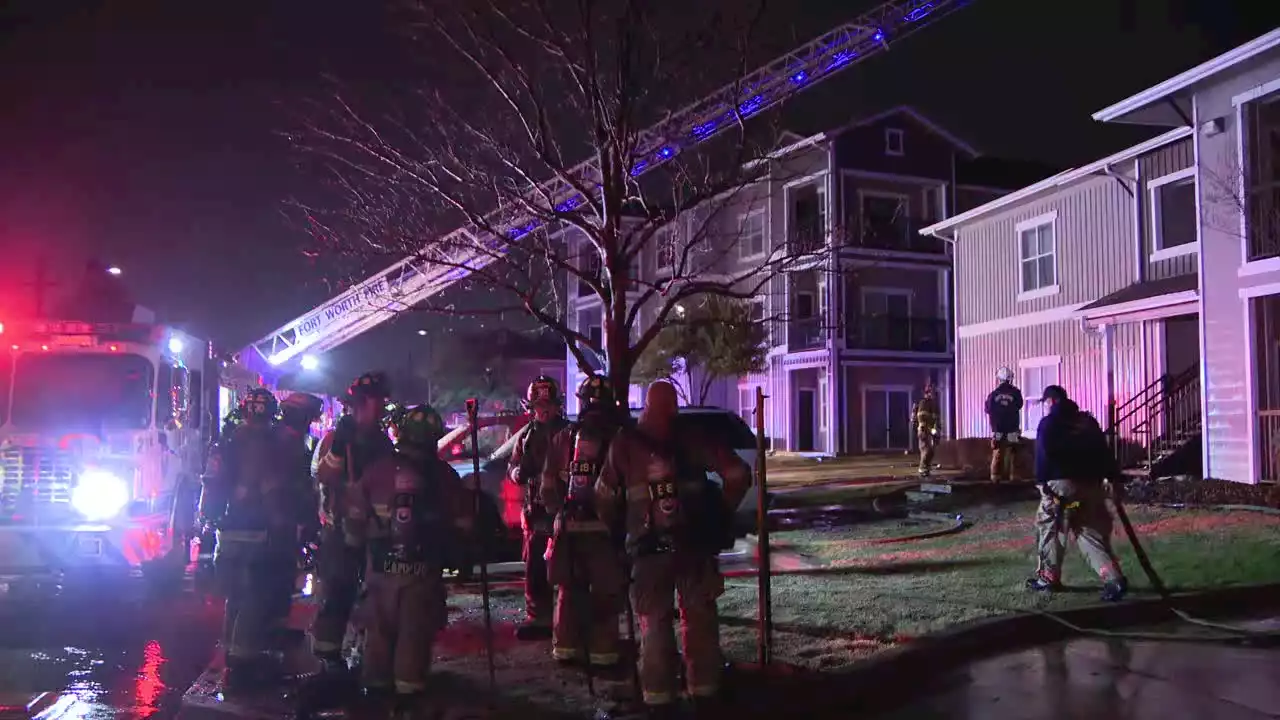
(311, 373, 393, 670)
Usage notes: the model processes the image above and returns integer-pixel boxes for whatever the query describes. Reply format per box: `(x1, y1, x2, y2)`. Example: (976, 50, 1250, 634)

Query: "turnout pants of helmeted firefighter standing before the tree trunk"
(548, 530, 626, 666)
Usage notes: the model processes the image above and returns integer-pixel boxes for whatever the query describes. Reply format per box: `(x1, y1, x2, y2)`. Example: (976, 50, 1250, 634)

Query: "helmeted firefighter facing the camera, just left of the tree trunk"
(507, 375, 568, 641)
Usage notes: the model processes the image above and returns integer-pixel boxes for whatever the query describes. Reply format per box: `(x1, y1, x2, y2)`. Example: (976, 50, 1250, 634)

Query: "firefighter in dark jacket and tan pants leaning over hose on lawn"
(1027, 386, 1128, 602)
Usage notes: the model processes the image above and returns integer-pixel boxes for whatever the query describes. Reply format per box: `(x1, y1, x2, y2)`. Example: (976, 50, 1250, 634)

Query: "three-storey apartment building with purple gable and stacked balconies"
(568, 106, 1047, 454)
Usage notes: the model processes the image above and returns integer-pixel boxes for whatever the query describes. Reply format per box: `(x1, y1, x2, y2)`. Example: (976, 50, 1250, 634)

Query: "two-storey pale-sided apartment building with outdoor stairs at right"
(922, 31, 1280, 483)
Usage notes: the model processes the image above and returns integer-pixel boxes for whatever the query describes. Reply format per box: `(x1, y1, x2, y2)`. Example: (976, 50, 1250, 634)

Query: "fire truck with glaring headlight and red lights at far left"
(0, 322, 220, 601)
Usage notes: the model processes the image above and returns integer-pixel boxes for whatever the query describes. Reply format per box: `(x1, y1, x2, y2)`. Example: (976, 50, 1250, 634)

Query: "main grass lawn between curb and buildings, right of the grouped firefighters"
(721, 502, 1280, 667)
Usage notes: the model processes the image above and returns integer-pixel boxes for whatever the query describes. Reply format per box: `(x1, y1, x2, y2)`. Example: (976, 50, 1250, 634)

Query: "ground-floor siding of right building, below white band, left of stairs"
(956, 320, 1158, 437)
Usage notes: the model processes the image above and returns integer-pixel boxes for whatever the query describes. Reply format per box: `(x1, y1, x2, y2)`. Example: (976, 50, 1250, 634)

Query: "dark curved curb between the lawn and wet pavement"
(735, 583, 1280, 717)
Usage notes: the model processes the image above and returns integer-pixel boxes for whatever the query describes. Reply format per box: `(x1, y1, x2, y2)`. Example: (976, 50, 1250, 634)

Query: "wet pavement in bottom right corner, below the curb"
(876, 630, 1280, 720)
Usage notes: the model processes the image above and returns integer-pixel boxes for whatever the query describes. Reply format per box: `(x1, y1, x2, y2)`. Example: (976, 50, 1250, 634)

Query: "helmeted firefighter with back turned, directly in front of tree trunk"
(541, 375, 627, 667)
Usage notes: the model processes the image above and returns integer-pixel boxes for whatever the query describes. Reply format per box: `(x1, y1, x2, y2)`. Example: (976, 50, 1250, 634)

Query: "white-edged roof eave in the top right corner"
(1093, 28, 1280, 127)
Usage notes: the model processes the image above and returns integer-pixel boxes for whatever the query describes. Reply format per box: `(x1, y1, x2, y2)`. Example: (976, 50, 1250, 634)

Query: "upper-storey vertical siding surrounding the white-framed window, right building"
(956, 177, 1137, 327)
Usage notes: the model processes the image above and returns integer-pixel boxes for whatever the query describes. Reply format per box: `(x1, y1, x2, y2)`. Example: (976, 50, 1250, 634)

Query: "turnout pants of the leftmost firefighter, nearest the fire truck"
(214, 533, 296, 661)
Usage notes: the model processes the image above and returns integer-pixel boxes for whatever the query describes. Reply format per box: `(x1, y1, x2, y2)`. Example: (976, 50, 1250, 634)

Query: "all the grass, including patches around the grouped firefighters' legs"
(436, 502, 1280, 720)
